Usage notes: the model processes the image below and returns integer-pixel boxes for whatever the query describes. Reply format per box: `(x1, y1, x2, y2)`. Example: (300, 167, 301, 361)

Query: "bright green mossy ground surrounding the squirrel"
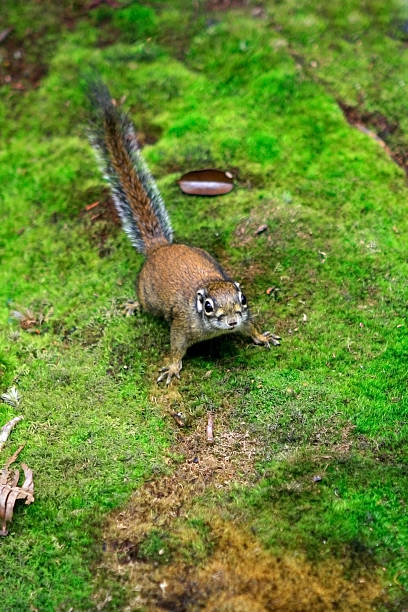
(0, 0, 408, 610)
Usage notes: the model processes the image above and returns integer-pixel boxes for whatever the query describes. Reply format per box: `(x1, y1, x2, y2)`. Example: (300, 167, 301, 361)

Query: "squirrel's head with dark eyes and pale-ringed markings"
(196, 281, 249, 332)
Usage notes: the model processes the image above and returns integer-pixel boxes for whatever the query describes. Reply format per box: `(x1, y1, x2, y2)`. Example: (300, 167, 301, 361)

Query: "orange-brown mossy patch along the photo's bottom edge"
(97, 513, 383, 612)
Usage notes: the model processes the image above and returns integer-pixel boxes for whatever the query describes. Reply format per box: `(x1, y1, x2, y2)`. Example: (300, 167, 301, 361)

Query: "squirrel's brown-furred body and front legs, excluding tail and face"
(138, 244, 278, 384)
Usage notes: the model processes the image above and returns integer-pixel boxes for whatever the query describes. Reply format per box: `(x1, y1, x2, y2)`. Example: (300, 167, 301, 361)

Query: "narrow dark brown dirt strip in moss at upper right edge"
(338, 100, 408, 176)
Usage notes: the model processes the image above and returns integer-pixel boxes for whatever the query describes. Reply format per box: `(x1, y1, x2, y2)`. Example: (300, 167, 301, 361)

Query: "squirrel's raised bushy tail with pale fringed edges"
(88, 82, 173, 253)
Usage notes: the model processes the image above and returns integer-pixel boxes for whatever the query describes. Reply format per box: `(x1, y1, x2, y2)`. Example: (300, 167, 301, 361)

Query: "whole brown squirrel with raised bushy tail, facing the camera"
(89, 83, 280, 385)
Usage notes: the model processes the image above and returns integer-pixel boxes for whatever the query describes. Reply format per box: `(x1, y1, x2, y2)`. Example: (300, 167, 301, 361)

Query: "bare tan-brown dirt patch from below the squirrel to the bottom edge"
(95, 389, 383, 612)
